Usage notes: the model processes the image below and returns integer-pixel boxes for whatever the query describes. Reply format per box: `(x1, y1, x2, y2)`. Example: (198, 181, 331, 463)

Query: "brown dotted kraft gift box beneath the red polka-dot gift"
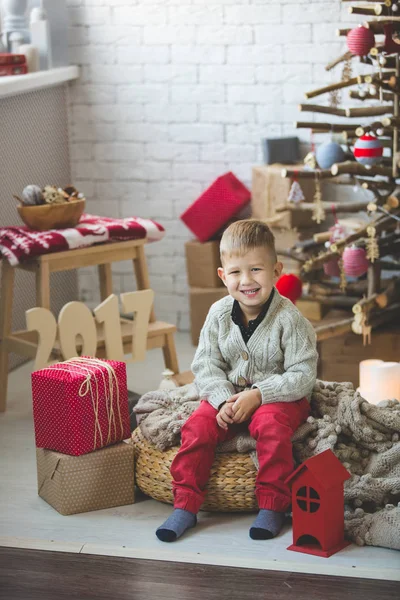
(36, 442, 135, 515)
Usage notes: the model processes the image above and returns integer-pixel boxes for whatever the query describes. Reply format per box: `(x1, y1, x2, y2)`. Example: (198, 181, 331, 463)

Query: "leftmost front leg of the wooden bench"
(0, 259, 14, 412)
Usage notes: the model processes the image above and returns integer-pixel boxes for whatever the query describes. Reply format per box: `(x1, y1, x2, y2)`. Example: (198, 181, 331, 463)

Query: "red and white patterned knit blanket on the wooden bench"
(0, 214, 165, 266)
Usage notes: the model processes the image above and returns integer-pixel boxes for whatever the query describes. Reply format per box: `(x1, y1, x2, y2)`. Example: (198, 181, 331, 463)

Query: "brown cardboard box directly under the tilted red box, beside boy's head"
(185, 240, 224, 288)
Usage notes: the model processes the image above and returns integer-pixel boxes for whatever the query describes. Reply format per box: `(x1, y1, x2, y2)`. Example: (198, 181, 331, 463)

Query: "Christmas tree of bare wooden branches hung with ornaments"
(277, 0, 400, 343)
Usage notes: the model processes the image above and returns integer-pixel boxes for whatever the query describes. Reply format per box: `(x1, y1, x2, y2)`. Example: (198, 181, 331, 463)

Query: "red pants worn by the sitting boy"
(171, 398, 310, 513)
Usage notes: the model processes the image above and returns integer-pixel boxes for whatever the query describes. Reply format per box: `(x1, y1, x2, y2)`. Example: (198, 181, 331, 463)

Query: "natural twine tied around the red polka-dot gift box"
(44, 356, 124, 450)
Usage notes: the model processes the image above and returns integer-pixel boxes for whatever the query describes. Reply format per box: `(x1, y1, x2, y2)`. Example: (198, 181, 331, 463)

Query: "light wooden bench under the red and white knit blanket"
(0, 239, 179, 412)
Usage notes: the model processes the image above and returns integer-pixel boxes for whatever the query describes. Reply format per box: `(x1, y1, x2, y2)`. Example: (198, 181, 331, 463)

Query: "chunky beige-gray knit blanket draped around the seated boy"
(135, 380, 400, 550)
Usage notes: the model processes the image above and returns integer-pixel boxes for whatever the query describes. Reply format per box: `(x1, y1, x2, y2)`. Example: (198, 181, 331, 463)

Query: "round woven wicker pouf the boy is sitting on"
(132, 427, 257, 512)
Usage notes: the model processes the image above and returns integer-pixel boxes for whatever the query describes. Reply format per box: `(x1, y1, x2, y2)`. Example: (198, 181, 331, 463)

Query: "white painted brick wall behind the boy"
(68, 0, 363, 329)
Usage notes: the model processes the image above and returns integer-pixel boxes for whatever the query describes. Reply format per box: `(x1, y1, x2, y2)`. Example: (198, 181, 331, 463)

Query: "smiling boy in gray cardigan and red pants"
(156, 219, 318, 542)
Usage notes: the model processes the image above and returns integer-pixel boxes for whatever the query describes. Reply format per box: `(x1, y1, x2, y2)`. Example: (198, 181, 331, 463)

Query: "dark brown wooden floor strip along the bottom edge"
(0, 548, 400, 600)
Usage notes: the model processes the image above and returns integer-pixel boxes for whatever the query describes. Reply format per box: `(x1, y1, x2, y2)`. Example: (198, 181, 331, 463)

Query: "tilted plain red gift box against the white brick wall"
(180, 173, 251, 242)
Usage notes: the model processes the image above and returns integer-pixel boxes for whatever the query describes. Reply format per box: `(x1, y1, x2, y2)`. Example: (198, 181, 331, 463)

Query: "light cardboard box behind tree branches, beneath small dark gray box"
(251, 164, 315, 229)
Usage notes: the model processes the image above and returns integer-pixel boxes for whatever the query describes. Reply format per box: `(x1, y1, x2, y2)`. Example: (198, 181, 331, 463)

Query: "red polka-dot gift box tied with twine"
(32, 357, 130, 456)
